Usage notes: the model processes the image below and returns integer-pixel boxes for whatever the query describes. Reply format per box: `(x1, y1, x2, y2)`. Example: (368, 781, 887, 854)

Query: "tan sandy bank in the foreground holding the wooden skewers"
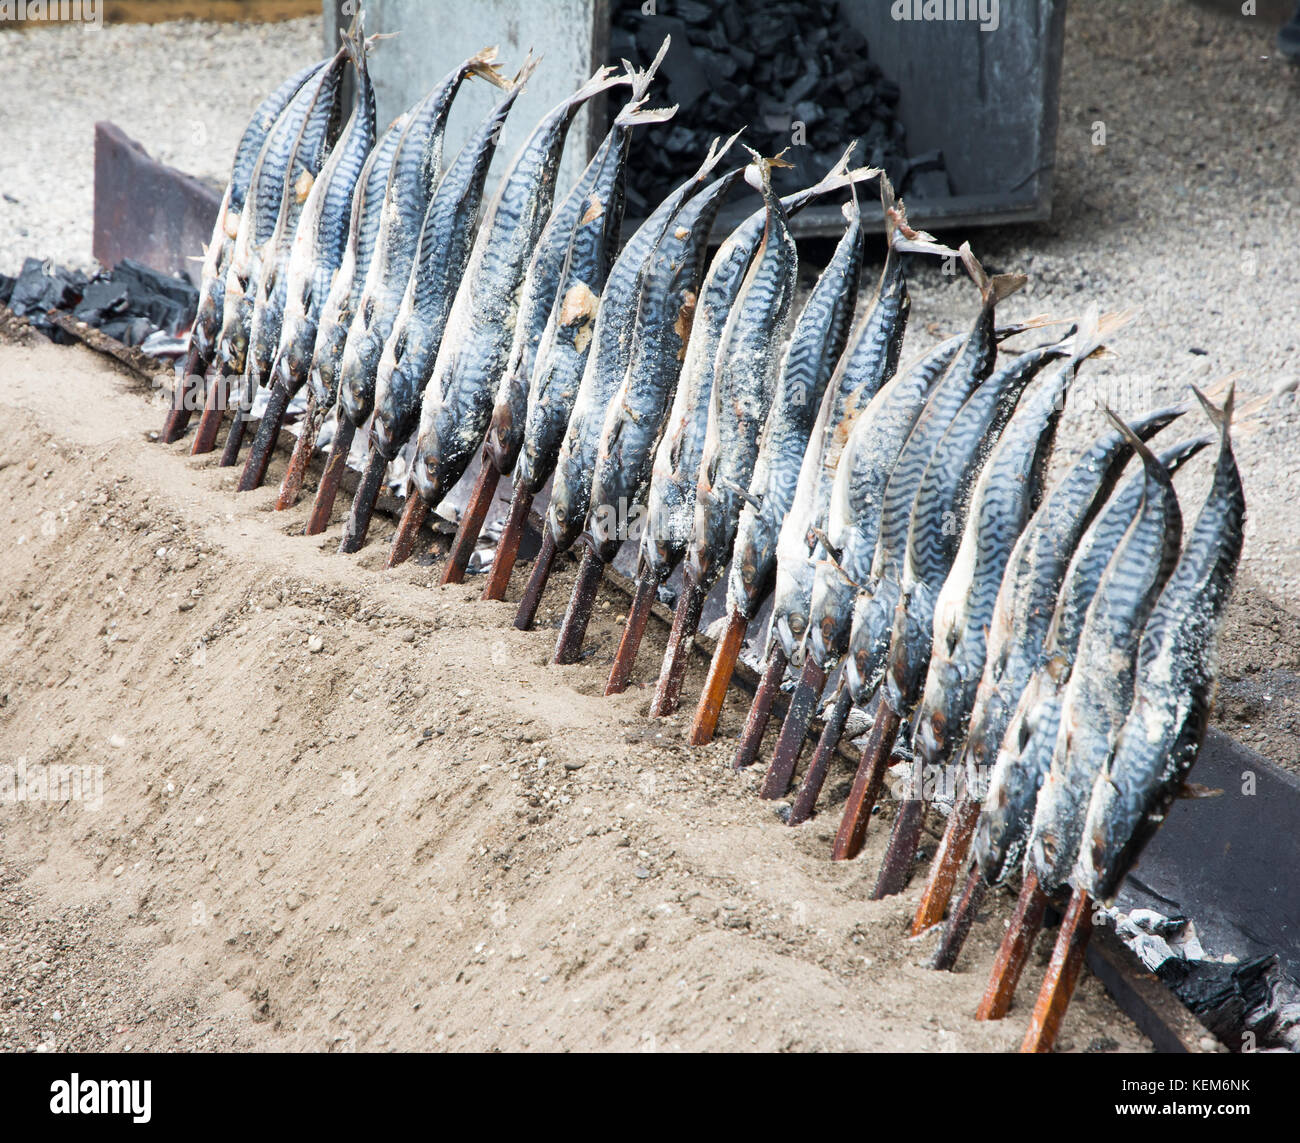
(0, 323, 1145, 1051)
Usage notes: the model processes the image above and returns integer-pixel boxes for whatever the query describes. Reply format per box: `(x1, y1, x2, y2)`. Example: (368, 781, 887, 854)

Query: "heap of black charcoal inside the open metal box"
(610, 0, 950, 210)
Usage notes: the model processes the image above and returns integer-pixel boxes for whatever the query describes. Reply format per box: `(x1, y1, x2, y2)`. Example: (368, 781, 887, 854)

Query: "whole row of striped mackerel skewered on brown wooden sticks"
(165, 20, 1244, 1055)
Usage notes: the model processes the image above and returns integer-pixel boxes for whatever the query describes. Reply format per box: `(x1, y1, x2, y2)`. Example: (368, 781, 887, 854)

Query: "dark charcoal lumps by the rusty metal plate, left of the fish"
(0, 257, 199, 346)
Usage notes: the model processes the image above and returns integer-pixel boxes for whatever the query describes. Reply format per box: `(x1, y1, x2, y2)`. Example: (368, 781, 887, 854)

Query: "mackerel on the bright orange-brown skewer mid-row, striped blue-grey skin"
(727, 195, 865, 619)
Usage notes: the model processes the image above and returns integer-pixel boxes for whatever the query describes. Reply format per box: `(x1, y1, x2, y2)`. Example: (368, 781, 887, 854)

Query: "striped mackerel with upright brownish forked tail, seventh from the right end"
(845, 258, 1027, 713)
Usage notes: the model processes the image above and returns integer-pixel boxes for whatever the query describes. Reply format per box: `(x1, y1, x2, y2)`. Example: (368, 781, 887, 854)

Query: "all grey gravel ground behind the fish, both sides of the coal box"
(0, 0, 1300, 610)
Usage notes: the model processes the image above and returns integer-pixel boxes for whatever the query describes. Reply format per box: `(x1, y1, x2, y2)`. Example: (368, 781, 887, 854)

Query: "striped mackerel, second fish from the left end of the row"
(217, 51, 347, 377)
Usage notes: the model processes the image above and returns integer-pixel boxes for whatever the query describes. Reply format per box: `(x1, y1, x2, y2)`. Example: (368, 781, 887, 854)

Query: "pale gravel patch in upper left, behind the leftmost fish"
(0, 20, 321, 274)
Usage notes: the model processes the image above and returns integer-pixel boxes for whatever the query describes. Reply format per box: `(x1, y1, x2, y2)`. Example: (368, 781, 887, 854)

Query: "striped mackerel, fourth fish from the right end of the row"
(963, 408, 1183, 801)
